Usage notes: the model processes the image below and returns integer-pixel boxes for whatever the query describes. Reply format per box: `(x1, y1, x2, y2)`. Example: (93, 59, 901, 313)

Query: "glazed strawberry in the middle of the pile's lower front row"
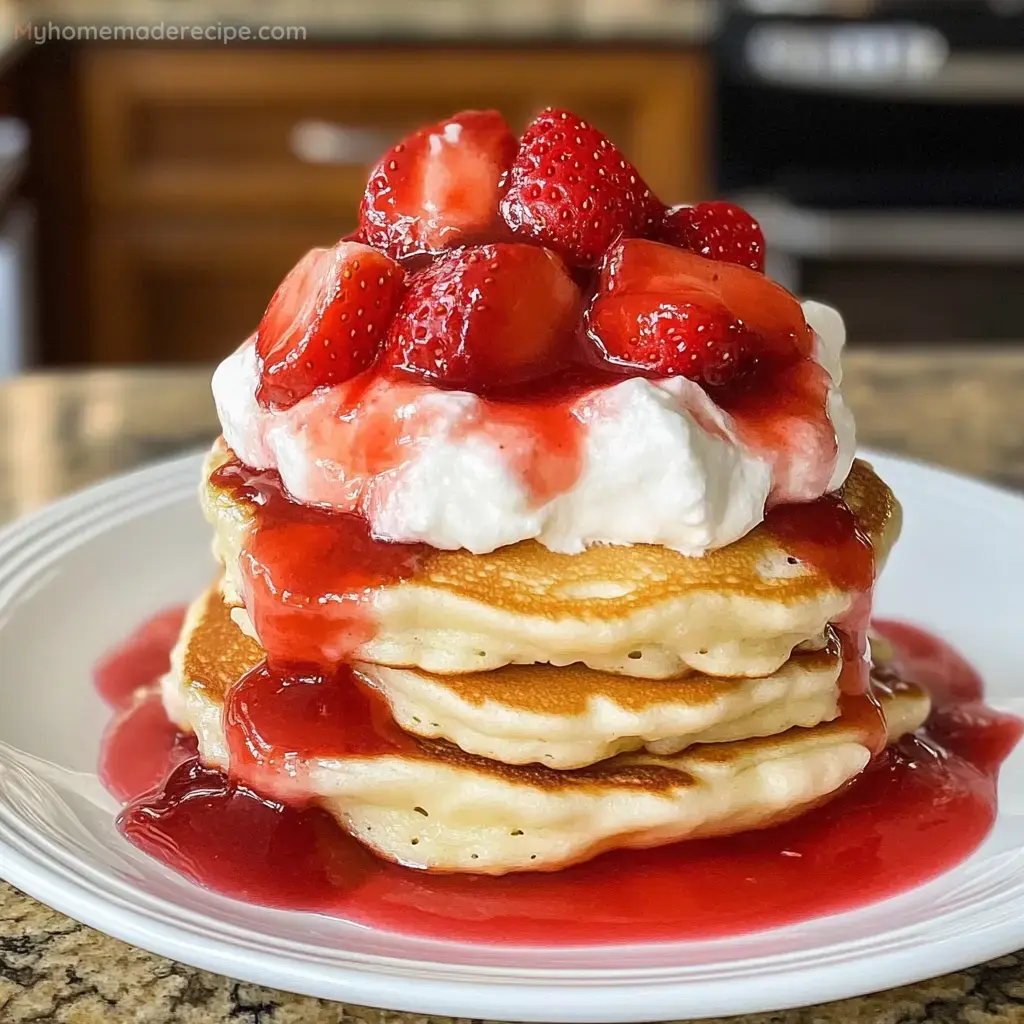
(384, 243, 581, 391)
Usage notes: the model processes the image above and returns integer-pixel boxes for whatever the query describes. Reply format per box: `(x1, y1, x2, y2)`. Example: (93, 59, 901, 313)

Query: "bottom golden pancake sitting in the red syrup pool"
(163, 595, 929, 873)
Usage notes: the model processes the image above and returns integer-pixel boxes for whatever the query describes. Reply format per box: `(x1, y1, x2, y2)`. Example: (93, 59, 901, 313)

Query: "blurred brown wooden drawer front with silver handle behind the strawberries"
(82, 47, 707, 213)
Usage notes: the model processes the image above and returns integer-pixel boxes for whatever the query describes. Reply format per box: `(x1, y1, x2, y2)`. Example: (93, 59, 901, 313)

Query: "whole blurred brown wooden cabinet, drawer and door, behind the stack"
(61, 47, 708, 362)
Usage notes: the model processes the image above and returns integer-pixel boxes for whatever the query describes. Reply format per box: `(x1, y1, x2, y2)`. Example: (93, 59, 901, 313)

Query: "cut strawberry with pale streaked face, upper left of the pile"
(358, 111, 516, 259)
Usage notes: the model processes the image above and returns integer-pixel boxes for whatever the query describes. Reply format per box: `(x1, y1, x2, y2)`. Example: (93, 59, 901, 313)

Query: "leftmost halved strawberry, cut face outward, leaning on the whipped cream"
(256, 242, 406, 407)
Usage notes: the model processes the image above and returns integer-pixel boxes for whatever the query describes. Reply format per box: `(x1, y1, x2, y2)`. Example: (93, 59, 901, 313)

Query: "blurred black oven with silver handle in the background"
(715, 0, 1024, 341)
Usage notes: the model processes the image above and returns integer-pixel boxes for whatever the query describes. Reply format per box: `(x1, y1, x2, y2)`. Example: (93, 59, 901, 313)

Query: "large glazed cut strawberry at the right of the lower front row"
(587, 239, 813, 384)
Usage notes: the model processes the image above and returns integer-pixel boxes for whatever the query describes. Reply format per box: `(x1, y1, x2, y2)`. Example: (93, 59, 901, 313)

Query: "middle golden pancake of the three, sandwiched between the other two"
(356, 643, 842, 769)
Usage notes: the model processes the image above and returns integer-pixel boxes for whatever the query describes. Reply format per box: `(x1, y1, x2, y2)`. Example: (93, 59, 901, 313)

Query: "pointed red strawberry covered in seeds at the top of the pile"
(502, 106, 660, 266)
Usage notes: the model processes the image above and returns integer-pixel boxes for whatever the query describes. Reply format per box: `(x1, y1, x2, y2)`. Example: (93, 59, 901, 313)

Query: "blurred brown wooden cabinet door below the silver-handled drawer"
(88, 217, 342, 364)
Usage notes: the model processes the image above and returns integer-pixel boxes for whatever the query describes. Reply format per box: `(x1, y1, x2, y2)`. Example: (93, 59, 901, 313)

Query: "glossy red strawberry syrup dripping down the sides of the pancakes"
(163, 456, 886, 831)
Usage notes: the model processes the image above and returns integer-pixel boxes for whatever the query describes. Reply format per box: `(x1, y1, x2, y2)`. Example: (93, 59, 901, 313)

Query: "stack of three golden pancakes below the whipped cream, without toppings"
(157, 440, 929, 873)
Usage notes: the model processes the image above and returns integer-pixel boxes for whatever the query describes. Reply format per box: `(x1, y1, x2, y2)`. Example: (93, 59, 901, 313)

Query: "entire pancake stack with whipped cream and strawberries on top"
(157, 108, 929, 874)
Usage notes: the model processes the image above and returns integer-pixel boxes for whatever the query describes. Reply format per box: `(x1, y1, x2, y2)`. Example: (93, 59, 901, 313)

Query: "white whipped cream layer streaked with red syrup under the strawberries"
(213, 302, 855, 555)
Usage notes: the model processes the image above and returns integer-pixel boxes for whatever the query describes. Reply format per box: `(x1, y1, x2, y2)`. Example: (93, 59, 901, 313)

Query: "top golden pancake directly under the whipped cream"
(203, 441, 901, 679)
